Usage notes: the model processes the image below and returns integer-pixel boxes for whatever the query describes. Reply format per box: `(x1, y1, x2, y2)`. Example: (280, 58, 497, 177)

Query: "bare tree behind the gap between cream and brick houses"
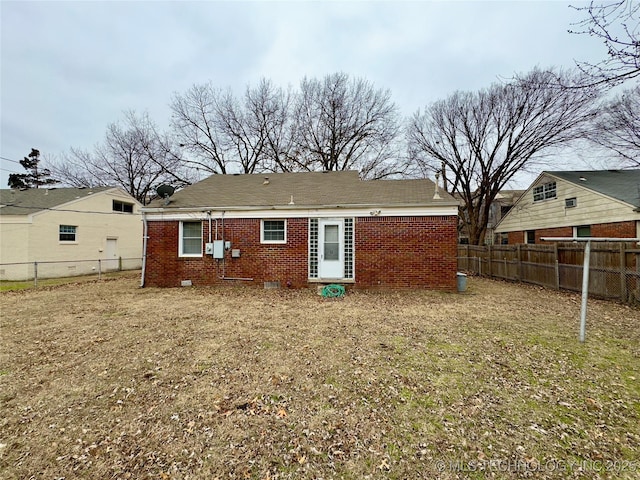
(53, 111, 193, 204)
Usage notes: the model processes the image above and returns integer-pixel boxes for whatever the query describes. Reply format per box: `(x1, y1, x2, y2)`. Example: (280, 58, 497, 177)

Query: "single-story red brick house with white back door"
(142, 171, 458, 290)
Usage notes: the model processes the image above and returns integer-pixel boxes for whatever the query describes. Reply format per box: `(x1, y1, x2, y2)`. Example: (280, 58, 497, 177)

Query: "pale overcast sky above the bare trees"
(0, 0, 606, 188)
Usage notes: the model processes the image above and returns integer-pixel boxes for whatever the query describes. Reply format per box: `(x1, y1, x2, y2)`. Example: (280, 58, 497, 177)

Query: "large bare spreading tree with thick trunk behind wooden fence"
(407, 69, 598, 245)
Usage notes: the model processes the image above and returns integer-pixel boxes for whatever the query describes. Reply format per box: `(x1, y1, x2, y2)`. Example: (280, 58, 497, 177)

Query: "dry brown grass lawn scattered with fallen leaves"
(0, 275, 640, 479)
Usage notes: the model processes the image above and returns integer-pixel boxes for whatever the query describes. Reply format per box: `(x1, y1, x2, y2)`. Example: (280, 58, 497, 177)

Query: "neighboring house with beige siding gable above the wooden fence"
(496, 170, 640, 244)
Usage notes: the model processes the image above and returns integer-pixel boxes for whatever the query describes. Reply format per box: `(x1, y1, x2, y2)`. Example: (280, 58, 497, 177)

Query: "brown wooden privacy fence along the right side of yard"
(458, 242, 640, 303)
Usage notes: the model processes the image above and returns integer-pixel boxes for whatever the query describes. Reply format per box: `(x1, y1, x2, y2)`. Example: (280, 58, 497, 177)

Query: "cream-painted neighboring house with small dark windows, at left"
(0, 187, 142, 280)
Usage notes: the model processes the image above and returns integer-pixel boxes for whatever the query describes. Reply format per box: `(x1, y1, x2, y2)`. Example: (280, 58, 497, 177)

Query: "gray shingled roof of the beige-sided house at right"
(545, 170, 640, 207)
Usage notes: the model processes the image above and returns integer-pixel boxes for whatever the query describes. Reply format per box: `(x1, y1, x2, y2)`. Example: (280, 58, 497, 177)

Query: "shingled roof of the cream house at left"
(0, 187, 113, 215)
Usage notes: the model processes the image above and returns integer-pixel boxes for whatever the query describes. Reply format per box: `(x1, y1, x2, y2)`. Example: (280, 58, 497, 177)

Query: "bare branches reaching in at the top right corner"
(569, 0, 640, 85)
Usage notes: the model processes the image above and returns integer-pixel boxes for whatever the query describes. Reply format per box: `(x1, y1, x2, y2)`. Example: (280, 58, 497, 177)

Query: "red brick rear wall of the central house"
(145, 216, 457, 290)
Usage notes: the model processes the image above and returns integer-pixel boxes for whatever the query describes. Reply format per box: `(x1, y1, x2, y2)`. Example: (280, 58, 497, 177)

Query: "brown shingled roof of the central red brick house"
(149, 171, 458, 209)
